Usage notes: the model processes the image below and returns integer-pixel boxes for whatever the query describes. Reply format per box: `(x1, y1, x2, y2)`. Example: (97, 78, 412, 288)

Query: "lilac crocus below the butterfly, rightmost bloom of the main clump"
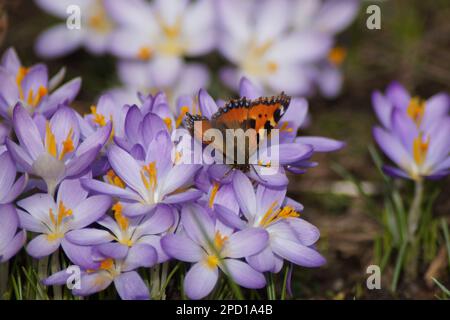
(214, 172, 325, 272)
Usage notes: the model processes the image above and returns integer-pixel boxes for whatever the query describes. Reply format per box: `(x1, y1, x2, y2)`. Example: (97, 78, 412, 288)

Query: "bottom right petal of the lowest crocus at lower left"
(114, 271, 150, 300)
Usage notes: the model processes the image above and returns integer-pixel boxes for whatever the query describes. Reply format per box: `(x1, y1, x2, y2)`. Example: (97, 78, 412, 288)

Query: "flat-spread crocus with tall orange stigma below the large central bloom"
(67, 202, 177, 263)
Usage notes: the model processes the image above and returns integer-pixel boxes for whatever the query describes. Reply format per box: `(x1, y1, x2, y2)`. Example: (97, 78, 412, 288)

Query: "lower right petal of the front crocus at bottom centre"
(224, 259, 266, 289)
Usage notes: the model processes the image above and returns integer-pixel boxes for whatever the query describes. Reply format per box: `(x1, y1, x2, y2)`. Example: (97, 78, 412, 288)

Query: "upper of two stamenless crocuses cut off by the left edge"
(0, 151, 28, 204)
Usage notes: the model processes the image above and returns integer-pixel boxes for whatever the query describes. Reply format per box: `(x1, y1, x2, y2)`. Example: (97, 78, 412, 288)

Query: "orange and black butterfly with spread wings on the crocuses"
(185, 92, 291, 172)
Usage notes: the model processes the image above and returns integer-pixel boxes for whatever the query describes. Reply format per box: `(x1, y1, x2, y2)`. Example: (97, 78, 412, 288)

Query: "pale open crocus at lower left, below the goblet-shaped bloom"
(17, 179, 111, 258)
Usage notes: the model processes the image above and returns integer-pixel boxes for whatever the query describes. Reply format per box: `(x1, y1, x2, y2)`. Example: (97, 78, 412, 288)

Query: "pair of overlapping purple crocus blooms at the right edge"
(372, 82, 450, 180)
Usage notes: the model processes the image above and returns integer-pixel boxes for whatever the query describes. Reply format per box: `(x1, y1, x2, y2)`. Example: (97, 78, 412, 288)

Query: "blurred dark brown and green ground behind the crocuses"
(0, 0, 450, 299)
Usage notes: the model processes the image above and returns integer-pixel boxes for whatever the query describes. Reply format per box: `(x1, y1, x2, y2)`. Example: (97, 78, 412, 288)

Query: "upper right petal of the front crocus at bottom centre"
(223, 228, 269, 258)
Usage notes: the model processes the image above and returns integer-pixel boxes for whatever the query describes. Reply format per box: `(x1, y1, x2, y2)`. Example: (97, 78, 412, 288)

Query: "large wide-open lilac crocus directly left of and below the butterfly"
(82, 132, 202, 216)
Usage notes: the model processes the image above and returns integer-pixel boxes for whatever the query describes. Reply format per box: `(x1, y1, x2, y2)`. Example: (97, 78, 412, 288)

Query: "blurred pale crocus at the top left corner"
(35, 0, 114, 58)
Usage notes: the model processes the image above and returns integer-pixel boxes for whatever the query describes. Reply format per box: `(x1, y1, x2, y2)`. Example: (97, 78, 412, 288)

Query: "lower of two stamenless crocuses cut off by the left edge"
(0, 204, 27, 263)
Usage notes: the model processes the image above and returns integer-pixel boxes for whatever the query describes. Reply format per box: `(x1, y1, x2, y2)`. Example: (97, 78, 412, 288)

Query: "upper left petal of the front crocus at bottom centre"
(161, 234, 204, 262)
